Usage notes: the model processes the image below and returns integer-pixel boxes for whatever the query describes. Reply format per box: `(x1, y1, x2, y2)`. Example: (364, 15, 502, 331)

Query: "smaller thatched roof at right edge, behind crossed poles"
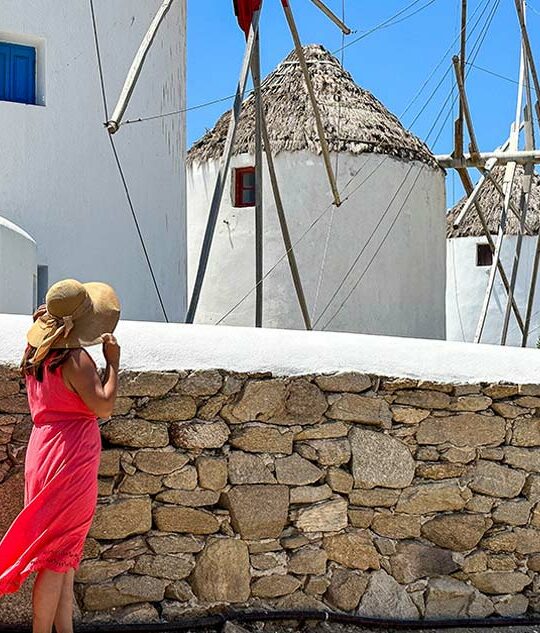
(447, 165, 540, 237)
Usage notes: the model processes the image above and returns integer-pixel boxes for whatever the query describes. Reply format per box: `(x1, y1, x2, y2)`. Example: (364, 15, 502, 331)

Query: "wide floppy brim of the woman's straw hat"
(27, 281, 120, 349)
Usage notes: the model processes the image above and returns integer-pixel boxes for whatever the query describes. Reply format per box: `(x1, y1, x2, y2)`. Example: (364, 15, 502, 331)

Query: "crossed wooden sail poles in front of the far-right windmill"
(437, 0, 540, 347)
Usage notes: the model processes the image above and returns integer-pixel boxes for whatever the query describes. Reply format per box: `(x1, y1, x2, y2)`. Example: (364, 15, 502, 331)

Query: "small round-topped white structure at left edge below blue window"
(0, 217, 37, 314)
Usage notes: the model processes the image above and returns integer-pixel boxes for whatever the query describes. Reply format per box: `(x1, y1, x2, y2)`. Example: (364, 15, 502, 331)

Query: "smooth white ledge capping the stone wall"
(0, 314, 540, 384)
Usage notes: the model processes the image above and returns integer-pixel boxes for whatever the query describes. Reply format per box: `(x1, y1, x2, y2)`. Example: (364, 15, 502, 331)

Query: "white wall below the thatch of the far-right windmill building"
(446, 235, 540, 347)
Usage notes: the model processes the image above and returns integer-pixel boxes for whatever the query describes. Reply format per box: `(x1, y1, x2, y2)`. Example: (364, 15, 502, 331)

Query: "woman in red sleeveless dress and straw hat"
(0, 279, 120, 633)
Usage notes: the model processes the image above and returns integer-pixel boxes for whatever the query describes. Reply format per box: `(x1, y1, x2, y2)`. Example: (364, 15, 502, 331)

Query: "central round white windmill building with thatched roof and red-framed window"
(187, 46, 446, 339)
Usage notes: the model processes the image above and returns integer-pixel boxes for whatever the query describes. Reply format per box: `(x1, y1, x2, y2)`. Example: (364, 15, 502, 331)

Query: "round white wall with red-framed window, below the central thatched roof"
(187, 152, 446, 339)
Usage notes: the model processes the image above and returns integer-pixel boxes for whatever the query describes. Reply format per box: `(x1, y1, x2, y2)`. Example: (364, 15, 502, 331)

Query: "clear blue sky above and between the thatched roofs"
(188, 0, 540, 203)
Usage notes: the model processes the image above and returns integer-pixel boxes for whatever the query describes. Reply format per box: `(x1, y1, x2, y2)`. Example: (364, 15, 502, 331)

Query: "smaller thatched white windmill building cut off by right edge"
(446, 166, 540, 347)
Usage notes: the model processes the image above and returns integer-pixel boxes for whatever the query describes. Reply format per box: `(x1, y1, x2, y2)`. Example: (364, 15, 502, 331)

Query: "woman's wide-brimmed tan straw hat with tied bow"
(27, 279, 120, 364)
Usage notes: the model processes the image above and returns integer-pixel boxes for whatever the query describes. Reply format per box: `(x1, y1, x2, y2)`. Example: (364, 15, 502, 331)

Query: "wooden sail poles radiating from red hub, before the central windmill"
(106, 0, 352, 329)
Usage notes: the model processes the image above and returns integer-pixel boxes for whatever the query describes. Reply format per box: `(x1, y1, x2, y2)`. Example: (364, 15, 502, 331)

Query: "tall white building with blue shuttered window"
(0, 0, 186, 320)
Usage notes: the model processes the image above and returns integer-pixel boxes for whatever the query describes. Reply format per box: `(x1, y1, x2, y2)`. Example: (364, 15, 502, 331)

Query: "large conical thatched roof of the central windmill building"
(188, 45, 437, 167)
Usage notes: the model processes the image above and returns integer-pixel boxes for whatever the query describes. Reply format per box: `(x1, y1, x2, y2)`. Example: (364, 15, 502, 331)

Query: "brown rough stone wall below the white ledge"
(0, 368, 540, 622)
